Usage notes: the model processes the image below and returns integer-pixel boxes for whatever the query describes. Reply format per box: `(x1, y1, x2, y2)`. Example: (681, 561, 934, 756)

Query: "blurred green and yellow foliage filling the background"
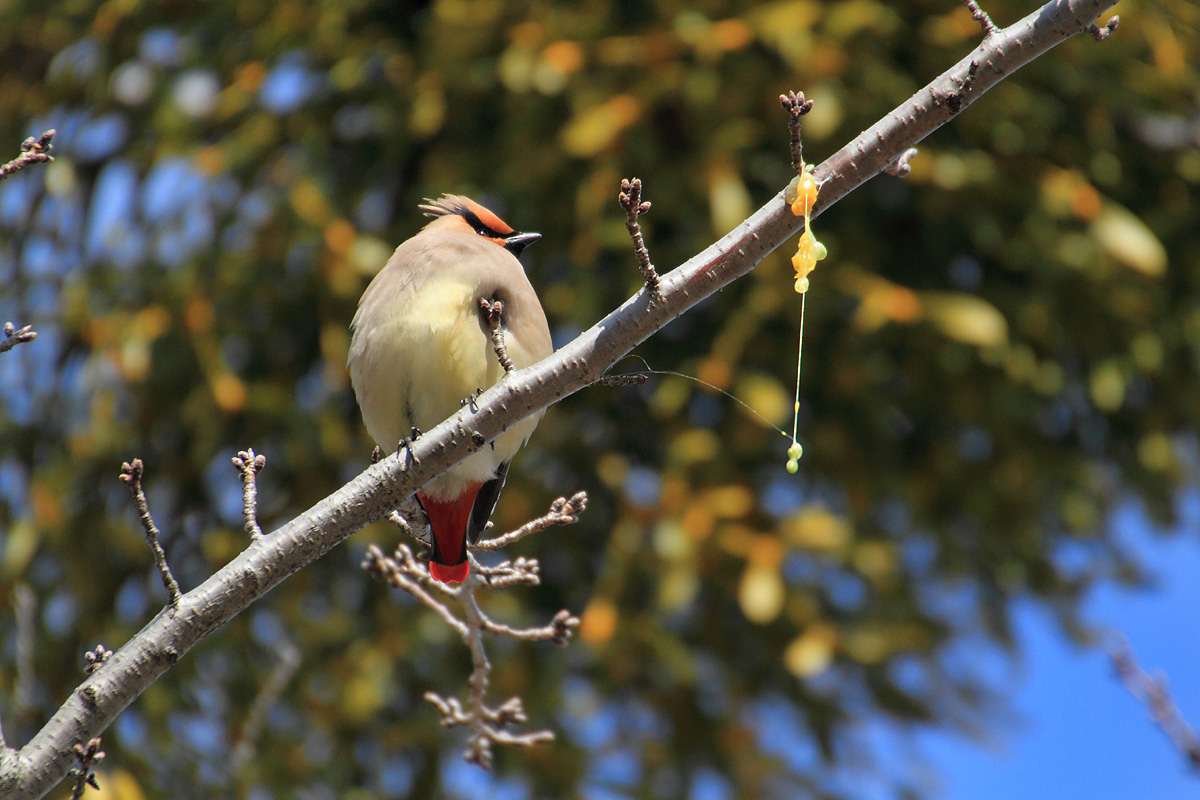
(0, 0, 1200, 799)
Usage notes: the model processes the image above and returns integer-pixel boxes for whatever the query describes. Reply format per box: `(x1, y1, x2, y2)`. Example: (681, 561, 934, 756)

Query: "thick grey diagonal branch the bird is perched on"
(0, 0, 1114, 799)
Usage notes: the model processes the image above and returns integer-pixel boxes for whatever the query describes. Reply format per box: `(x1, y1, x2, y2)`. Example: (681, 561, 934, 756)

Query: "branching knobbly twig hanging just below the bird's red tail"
(362, 492, 587, 769)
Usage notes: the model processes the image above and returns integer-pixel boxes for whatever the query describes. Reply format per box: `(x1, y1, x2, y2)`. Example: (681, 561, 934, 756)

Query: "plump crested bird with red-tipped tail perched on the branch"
(347, 194, 553, 583)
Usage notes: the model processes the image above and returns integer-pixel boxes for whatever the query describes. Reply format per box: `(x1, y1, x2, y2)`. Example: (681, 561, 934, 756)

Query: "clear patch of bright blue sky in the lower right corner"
(920, 493, 1200, 800)
